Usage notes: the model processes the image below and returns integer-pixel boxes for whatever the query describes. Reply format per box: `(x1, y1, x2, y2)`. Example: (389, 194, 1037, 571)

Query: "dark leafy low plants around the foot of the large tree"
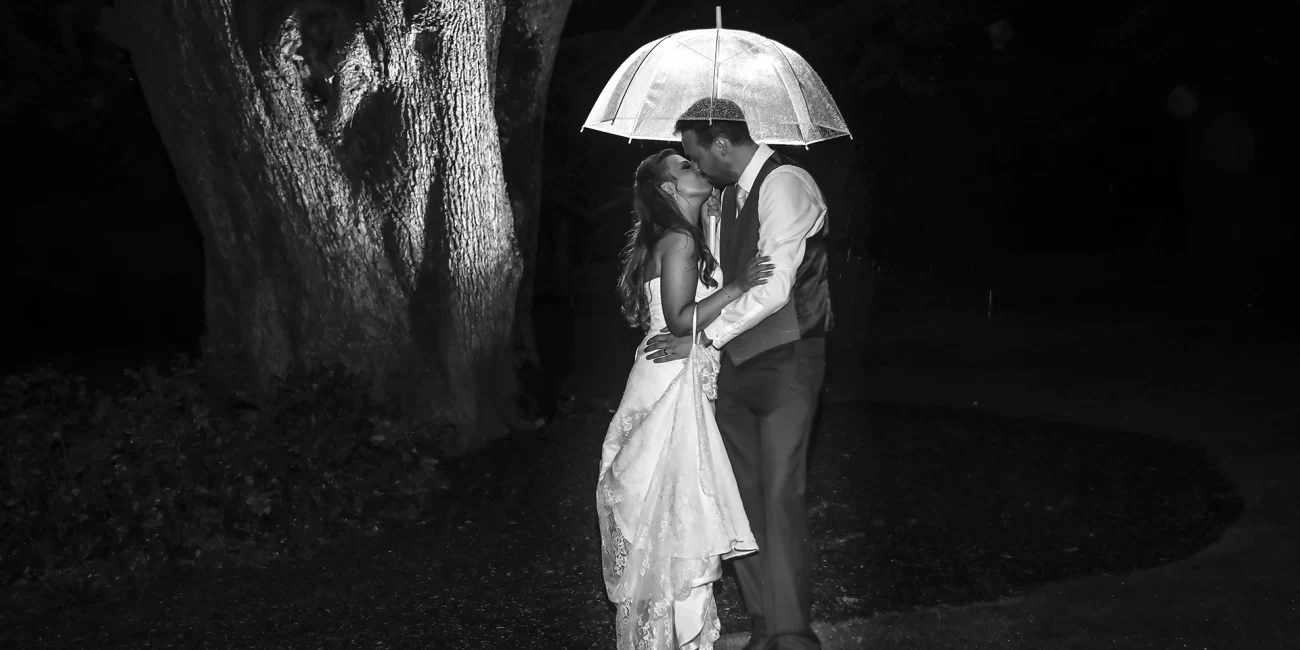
(0, 359, 445, 598)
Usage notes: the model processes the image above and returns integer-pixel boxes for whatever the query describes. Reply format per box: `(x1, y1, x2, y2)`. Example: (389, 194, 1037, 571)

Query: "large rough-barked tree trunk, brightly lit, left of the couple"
(120, 0, 553, 452)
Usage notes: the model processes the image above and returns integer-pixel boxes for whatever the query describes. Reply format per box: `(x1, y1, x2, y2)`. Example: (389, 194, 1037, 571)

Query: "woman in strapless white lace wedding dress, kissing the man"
(595, 150, 772, 650)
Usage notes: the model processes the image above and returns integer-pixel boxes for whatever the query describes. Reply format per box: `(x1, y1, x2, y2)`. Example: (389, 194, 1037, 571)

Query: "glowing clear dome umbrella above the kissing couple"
(582, 9, 849, 146)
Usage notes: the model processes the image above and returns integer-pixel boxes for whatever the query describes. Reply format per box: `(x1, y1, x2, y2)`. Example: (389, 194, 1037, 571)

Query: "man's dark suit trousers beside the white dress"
(716, 338, 826, 650)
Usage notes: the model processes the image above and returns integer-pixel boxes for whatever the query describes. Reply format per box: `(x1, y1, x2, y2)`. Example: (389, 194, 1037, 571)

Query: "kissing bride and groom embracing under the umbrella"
(595, 98, 833, 650)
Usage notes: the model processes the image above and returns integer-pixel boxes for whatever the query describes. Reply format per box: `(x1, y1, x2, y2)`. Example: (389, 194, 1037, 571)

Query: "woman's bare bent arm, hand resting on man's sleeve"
(659, 233, 766, 337)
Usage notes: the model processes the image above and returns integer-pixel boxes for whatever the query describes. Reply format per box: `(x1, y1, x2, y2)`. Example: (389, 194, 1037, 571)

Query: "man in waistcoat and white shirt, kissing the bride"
(646, 98, 832, 650)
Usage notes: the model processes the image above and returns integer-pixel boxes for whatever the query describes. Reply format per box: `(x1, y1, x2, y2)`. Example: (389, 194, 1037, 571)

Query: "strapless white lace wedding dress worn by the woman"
(595, 278, 758, 650)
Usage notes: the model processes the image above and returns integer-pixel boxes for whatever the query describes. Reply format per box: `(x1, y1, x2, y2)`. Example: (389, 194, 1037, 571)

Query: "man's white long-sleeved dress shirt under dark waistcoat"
(705, 144, 826, 348)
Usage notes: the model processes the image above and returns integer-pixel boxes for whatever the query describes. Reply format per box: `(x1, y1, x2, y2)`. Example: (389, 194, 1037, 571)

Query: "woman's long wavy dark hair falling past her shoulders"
(619, 150, 718, 329)
